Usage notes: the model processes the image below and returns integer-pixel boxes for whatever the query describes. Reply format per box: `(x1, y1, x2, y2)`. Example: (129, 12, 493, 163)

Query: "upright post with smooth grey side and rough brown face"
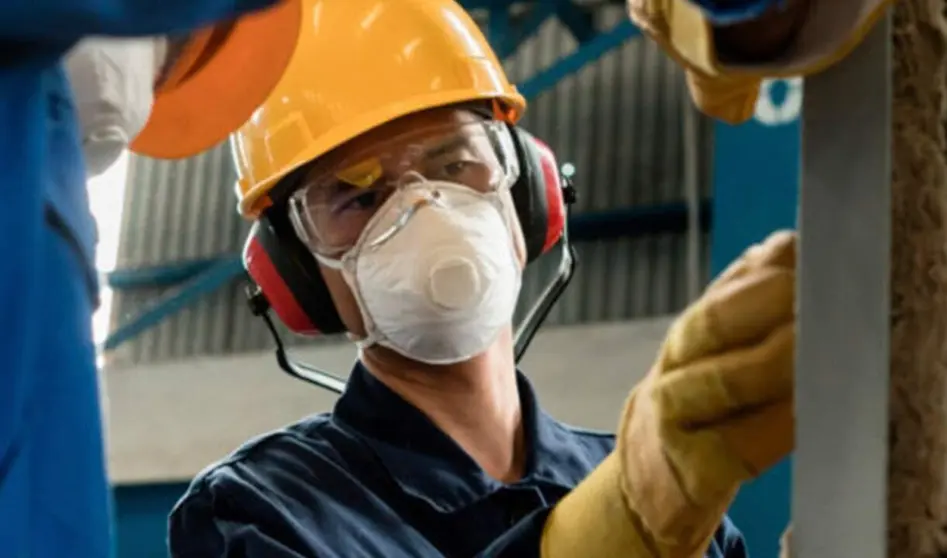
(792, 0, 947, 558)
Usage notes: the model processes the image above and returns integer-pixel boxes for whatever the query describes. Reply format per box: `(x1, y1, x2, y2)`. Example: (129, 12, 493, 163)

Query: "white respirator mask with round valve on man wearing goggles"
(316, 180, 521, 365)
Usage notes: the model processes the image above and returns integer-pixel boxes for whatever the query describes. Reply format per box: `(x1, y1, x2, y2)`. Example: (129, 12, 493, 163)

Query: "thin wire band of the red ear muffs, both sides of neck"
(246, 165, 576, 393)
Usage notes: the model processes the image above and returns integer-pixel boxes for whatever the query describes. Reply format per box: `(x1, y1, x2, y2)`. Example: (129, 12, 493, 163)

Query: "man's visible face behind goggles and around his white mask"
(293, 108, 526, 336)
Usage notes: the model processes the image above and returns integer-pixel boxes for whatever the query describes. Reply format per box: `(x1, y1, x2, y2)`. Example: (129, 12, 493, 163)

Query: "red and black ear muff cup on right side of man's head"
(510, 127, 566, 262)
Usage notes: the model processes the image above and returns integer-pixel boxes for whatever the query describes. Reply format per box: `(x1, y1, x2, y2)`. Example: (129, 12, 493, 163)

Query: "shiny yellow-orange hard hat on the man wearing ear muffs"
(232, 0, 526, 218)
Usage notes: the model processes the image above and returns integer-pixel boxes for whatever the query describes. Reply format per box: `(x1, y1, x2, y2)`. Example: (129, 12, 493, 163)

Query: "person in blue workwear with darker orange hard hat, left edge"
(0, 0, 299, 558)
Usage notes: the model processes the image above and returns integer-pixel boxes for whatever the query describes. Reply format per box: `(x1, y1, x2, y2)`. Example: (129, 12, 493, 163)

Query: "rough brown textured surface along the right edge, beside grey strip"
(888, 0, 947, 558)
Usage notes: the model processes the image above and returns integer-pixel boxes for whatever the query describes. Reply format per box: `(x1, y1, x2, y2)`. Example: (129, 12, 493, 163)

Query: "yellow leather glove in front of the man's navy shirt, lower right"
(542, 232, 796, 558)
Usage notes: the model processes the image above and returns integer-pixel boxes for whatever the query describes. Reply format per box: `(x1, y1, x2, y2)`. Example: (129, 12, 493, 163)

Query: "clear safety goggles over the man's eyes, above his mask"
(289, 121, 520, 258)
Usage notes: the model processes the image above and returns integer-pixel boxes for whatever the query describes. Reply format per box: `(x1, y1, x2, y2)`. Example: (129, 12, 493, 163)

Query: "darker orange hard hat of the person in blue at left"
(129, 0, 300, 159)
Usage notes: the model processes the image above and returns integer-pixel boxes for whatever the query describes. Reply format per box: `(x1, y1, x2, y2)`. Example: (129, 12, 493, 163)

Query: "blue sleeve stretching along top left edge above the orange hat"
(0, 0, 278, 44)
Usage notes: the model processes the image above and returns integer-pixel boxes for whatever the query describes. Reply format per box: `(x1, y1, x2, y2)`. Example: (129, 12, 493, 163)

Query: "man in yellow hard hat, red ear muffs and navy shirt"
(169, 0, 795, 558)
